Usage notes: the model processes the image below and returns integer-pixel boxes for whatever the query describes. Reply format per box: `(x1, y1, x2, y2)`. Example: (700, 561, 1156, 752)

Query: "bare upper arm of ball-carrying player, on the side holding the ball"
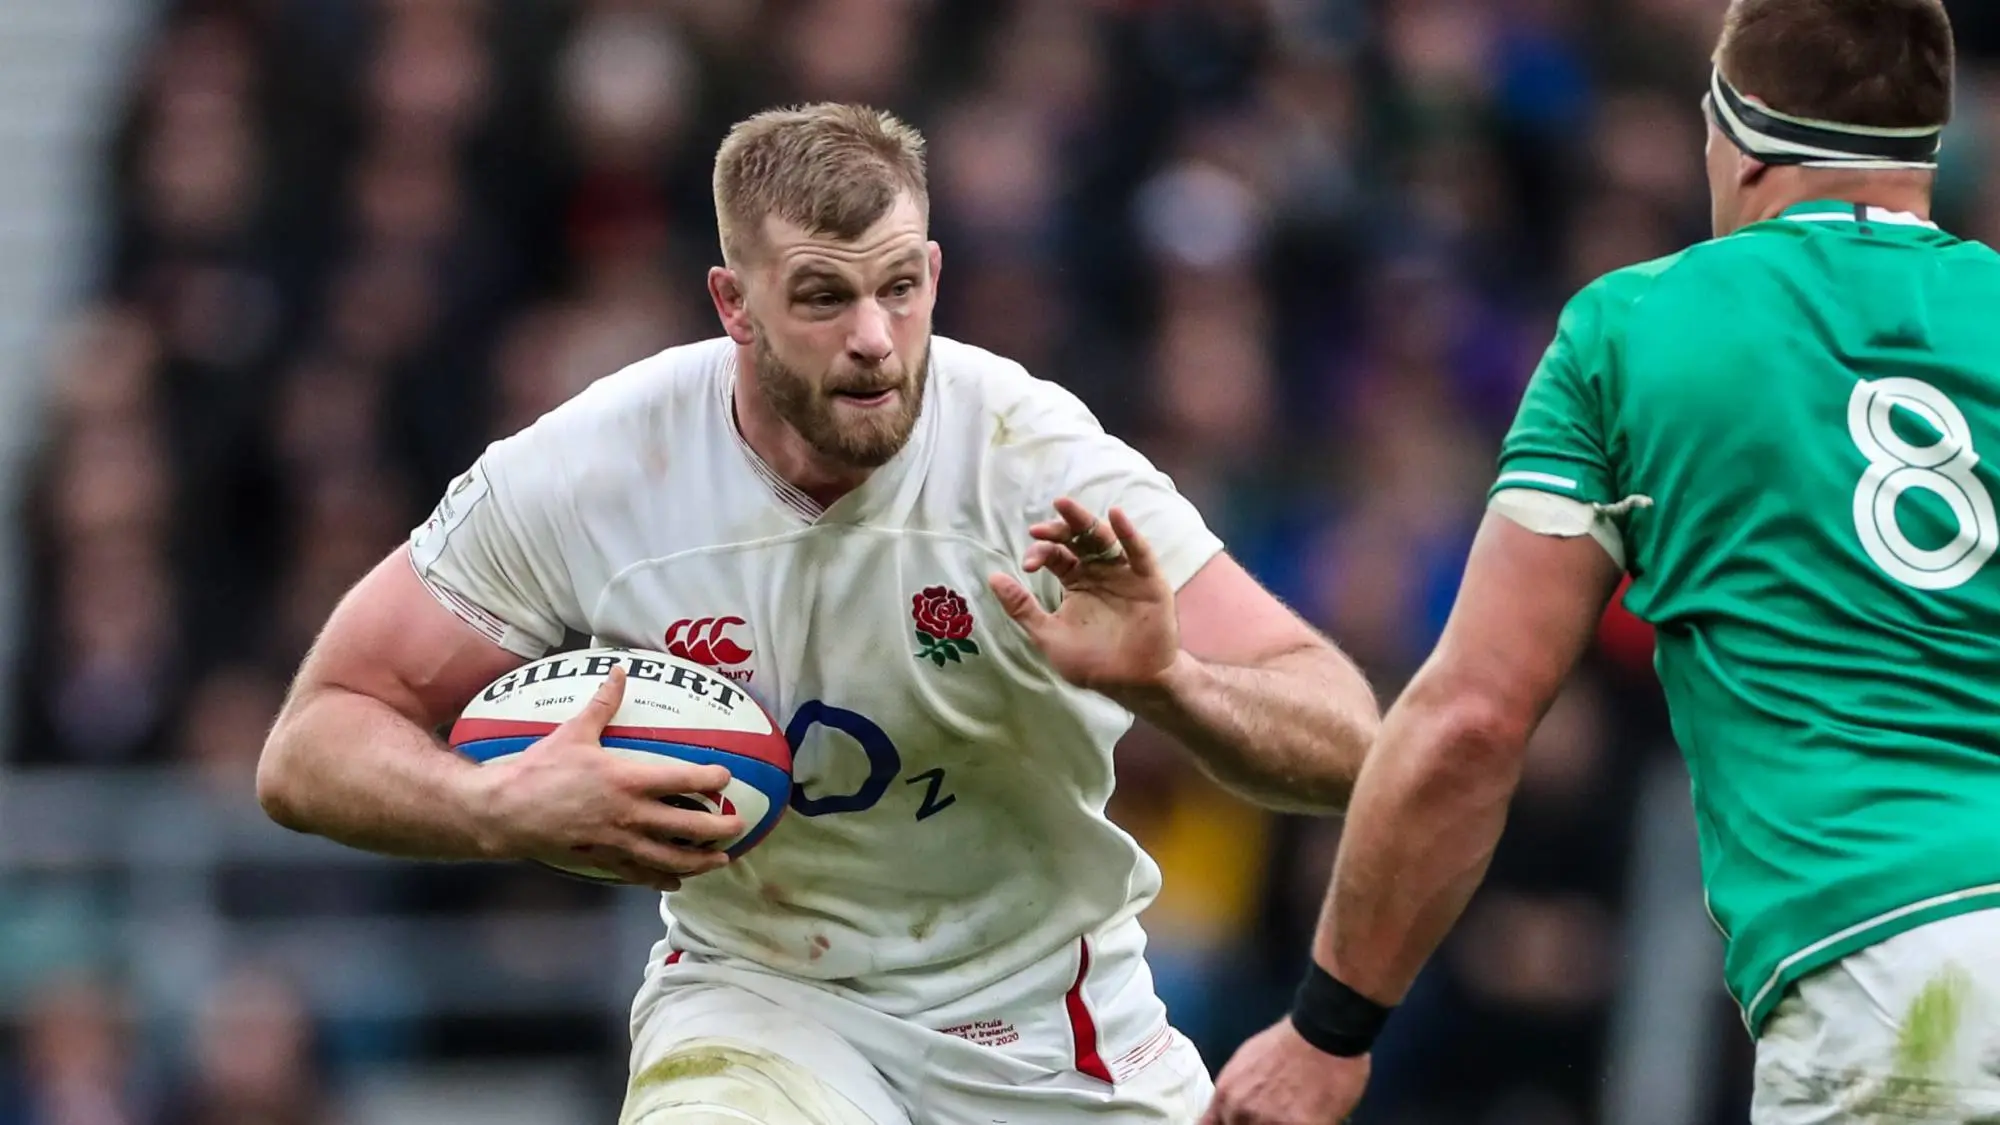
(292, 546, 524, 729)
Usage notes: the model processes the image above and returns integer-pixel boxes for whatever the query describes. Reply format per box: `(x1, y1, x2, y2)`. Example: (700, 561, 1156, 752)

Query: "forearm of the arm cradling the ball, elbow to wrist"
(258, 689, 492, 859)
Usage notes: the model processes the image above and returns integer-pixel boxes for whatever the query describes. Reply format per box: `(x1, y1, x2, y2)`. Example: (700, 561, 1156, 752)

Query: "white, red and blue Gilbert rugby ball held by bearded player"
(450, 649, 792, 883)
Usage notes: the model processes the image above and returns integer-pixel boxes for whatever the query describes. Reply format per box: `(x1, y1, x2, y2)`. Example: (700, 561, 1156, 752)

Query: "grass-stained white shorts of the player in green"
(1750, 911, 2000, 1125)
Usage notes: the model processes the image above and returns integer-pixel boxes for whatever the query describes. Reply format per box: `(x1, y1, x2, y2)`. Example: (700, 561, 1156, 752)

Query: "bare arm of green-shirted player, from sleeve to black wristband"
(1314, 514, 1618, 1005)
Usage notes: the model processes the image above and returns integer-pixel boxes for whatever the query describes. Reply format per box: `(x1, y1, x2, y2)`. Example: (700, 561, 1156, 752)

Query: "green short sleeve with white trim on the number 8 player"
(1494, 286, 1618, 504)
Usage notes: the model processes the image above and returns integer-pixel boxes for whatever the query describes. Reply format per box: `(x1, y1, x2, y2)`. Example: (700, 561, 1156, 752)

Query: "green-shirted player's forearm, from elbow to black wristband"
(1314, 703, 1524, 1005)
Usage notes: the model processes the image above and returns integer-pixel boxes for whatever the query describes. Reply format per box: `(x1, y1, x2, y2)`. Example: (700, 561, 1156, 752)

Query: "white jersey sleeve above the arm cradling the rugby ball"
(410, 428, 586, 661)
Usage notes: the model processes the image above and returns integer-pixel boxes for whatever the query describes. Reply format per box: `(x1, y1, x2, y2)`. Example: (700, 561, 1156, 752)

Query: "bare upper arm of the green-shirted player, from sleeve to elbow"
(1412, 512, 1618, 739)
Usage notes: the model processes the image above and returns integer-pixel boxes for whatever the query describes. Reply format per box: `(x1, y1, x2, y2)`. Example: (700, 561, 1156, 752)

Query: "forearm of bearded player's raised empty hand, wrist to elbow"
(1120, 645, 1380, 813)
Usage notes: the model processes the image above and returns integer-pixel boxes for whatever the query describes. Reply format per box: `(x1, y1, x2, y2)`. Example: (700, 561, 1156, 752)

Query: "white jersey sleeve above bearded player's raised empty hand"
(1028, 384, 1222, 591)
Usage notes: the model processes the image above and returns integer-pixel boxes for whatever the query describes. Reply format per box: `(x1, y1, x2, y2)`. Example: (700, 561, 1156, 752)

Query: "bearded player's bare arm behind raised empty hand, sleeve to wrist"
(1116, 554, 1380, 813)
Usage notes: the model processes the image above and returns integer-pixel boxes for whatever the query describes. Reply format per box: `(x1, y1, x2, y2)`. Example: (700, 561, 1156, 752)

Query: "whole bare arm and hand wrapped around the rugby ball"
(258, 548, 742, 891)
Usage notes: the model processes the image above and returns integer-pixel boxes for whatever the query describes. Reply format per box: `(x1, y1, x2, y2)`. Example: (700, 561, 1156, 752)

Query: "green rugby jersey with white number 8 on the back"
(1494, 202, 2000, 1033)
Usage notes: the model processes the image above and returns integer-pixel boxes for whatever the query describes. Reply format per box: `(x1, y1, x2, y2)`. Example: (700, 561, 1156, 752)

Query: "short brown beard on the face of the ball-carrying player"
(754, 330, 930, 468)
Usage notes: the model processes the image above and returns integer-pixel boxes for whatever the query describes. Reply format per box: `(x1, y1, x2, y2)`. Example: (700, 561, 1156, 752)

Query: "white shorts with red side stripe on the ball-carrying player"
(620, 936, 1214, 1125)
